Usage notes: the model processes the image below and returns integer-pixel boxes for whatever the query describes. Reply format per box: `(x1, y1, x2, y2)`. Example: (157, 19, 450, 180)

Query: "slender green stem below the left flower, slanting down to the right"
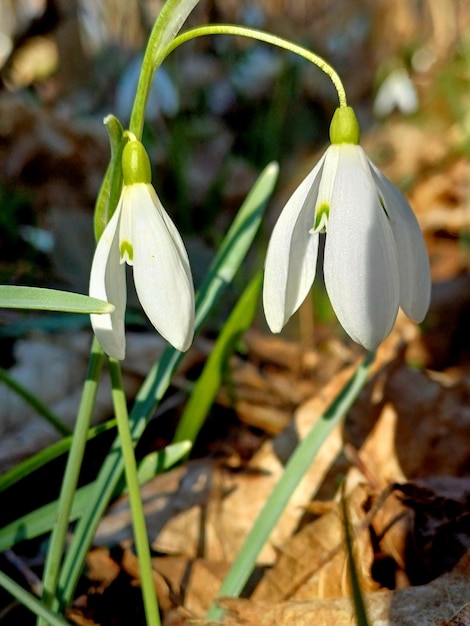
(109, 358, 160, 626)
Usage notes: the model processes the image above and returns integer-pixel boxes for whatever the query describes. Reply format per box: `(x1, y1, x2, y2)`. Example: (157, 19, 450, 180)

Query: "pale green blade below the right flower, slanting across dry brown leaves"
(207, 353, 374, 622)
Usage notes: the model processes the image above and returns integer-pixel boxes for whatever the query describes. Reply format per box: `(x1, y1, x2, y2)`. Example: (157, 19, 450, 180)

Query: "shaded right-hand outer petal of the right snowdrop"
(369, 161, 431, 322)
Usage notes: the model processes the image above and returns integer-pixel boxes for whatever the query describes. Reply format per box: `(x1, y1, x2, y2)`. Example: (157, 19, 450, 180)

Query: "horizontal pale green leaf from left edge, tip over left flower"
(0, 285, 114, 314)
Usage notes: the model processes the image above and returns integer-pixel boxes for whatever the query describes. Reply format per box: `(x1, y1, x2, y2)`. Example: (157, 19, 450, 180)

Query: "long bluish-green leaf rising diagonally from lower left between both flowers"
(60, 163, 278, 608)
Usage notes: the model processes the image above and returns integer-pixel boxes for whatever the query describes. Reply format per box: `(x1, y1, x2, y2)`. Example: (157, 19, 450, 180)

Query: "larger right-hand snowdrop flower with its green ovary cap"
(263, 107, 431, 350)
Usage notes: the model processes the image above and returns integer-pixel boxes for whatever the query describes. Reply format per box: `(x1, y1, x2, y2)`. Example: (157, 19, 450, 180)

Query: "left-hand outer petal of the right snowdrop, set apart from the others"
(263, 155, 325, 333)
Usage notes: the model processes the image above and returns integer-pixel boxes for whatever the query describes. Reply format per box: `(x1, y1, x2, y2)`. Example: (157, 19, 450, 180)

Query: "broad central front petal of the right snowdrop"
(323, 144, 399, 350)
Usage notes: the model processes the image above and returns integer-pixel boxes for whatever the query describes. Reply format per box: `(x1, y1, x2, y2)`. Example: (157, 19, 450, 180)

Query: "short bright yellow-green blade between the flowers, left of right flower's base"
(173, 272, 263, 444)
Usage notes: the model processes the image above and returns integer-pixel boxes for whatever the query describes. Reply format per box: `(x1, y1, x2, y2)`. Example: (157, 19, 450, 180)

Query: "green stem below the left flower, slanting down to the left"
(38, 339, 104, 626)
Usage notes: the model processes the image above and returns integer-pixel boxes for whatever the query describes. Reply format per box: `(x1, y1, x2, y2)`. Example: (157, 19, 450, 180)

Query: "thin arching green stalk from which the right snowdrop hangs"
(165, 24, 347, 107)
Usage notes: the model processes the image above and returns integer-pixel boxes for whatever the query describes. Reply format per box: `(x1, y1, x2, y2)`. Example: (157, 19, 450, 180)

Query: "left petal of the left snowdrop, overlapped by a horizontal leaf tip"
(90, 198, 127, 359)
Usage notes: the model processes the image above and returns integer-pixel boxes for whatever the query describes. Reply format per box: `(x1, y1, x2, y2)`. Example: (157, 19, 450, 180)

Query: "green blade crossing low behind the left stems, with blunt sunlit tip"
(0, 438, 191, 552)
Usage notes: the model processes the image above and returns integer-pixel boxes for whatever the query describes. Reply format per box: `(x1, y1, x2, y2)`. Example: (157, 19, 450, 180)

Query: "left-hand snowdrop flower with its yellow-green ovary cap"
(90, 140, 194, 359)
